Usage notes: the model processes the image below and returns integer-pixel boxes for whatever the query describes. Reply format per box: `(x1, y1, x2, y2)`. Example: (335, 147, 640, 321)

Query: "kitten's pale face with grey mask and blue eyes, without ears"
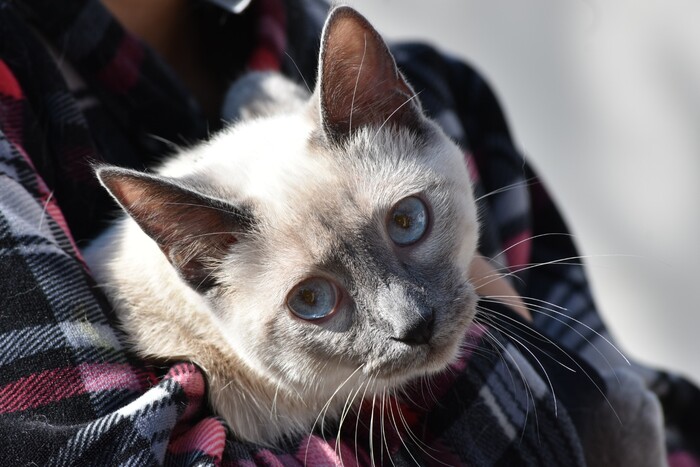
(205, 122, 477, 392)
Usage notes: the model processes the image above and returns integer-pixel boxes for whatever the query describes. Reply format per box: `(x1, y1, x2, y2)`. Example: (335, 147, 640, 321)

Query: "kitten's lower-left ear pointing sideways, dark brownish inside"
(96, 166, 252, 291)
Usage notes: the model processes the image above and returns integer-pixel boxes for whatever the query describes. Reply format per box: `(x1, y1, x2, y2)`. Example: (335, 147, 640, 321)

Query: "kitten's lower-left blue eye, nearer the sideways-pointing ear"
(287, 277, 338, 320)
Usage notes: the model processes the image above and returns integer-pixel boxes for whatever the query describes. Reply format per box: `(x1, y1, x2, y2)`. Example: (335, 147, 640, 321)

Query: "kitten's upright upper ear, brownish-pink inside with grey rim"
(316, 6, 421, 142)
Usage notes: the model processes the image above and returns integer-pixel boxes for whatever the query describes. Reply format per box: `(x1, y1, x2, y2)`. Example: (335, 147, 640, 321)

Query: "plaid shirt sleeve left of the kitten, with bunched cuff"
(0, 60, 225, 465)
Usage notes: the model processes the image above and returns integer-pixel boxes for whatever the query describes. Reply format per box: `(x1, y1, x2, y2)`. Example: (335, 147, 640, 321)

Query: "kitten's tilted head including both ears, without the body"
(98, 7, 478, 394)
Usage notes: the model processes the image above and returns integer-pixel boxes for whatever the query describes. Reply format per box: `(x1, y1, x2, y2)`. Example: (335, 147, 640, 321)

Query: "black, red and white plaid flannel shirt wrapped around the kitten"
(0, 0, 700, 466)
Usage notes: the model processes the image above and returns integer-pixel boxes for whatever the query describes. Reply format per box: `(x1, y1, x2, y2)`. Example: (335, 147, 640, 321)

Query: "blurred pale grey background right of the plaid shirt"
(345, 0, 700, 382)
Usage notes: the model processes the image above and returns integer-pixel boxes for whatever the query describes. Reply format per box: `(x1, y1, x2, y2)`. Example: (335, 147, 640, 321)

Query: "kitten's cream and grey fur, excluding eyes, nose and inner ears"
(85, 9, 478, 444)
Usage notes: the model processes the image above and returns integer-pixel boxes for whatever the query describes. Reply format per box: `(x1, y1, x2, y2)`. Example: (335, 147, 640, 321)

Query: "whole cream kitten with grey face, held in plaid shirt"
(80, 7, 478, 445)
